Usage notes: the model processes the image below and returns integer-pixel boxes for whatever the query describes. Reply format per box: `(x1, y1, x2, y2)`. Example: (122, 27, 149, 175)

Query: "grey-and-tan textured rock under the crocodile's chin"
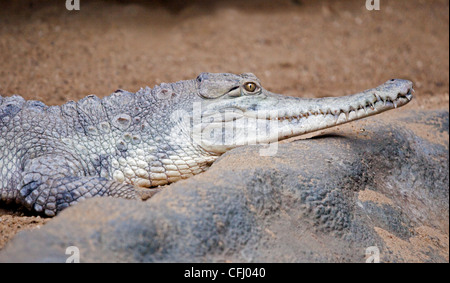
(0, 111, 449, 262)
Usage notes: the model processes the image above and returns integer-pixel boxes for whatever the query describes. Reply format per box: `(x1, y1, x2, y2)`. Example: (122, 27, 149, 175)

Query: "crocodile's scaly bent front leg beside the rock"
(16, 156, 142, 216)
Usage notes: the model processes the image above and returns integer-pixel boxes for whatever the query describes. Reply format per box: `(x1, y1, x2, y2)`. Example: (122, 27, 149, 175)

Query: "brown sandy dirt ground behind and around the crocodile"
(0, 0, 449, 253)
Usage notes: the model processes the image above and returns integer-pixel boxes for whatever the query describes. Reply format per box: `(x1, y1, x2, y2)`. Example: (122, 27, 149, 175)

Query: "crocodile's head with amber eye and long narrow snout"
(174, 73, 413, 154)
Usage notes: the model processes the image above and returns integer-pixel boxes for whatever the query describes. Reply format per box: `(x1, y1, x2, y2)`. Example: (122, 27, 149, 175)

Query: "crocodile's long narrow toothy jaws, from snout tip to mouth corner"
(201, 80, 414, 131)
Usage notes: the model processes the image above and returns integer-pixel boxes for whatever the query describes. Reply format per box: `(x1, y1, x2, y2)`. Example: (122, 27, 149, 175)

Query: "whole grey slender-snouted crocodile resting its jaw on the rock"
(0, 73, 413, 216)
